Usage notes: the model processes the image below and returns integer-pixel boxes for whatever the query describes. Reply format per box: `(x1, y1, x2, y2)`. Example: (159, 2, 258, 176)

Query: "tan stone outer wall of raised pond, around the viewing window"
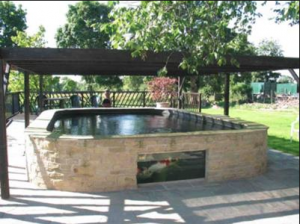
(27, 130, 267, 192)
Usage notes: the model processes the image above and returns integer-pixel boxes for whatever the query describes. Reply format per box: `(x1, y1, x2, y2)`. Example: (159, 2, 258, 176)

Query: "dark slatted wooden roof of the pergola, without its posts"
(0, 48, 299, 76)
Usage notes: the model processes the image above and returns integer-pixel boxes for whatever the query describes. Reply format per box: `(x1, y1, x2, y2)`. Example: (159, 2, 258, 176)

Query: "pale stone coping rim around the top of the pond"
(25, 108, 269, 140)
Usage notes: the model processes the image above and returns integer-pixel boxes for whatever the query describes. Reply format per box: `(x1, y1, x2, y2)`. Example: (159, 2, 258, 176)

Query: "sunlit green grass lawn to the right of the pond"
(203, 108, 299, 156)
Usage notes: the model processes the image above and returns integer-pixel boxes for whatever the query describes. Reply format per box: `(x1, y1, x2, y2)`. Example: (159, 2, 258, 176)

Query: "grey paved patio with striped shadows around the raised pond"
(0, 114, 299, 224)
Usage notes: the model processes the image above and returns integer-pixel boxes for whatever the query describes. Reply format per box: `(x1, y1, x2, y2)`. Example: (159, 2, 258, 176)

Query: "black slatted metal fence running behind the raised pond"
(6, 91, 201, 118)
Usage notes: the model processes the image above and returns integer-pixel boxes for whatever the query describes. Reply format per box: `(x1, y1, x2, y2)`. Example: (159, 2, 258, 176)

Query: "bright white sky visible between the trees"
(13, 1, 299, 76)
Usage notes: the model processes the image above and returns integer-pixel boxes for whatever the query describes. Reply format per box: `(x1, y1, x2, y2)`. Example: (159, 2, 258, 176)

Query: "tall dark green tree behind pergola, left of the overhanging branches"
(56, 1, 122, 89)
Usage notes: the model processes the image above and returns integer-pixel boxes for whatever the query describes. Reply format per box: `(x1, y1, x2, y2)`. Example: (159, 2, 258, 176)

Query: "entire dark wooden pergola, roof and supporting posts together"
(0, 48, 300, 199)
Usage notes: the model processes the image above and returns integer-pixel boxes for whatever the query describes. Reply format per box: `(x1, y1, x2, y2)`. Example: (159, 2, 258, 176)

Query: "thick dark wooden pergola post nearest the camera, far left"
(0, 60, 10, 200)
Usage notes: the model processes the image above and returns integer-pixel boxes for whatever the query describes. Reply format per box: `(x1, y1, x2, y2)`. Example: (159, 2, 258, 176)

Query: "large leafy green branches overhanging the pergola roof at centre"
(107, 1, 257, 74)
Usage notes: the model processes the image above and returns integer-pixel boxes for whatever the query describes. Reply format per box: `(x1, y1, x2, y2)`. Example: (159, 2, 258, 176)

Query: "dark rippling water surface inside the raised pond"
(53, 114, 231, 136)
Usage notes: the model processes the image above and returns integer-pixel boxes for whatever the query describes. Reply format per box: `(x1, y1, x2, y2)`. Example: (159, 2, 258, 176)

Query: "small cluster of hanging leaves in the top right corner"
(274, 1, 299, 26)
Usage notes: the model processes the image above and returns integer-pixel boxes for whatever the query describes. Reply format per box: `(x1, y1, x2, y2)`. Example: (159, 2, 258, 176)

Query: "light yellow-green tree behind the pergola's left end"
(9, 26, 59, 92)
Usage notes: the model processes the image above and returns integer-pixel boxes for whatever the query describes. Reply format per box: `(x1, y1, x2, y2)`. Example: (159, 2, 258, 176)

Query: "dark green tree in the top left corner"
(0, 1, 27, 47)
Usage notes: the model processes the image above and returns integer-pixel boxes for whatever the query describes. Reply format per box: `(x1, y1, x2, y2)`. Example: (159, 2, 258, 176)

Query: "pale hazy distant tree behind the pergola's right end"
(253, 40, 284, 82)
